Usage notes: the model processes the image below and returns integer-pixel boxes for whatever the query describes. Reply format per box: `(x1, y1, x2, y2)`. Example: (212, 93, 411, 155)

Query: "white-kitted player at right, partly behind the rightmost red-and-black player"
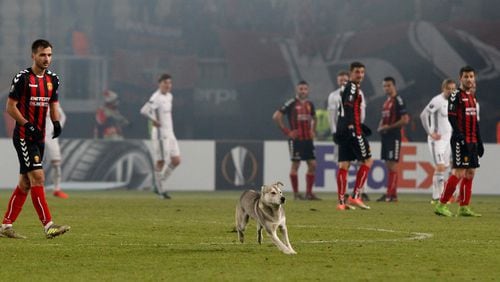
(420, 79, 456, 204)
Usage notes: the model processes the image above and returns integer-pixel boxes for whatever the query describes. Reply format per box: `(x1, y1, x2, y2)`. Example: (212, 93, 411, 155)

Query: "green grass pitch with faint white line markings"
(0, 191, 500, 281)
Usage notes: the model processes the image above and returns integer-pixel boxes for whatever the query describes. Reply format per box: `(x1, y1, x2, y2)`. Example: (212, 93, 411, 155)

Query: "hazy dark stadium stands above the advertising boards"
(0, 0, 500, 142)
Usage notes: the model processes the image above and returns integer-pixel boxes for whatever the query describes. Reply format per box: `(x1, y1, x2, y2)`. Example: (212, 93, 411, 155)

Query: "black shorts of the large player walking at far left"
(12, 138, 45, 174)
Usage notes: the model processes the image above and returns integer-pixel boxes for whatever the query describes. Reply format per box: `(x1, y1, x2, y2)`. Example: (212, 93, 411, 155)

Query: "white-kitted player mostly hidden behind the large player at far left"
(45, 106, 69, 199)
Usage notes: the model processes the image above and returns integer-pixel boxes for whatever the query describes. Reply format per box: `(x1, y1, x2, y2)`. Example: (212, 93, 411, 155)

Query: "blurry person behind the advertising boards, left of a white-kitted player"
(94, 90, 129, 140)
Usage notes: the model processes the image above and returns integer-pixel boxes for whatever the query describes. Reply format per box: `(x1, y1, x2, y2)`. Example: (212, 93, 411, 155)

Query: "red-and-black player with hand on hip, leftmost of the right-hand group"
(273, 81, 320, 200)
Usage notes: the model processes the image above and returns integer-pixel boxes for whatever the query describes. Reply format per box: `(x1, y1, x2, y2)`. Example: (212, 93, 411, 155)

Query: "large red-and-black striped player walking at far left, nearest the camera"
(0, 39, 70, 239)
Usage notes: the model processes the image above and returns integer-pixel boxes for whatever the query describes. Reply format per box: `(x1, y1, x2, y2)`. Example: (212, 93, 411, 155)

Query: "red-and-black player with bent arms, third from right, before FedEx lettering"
(377, 76, 410, 202)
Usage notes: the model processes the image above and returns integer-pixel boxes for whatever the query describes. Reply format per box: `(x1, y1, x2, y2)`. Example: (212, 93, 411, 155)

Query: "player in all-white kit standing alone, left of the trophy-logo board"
(141, 74, 181, 199)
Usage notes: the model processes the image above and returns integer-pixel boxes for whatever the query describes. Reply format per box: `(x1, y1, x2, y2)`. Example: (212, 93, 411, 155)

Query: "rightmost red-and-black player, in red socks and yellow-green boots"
(434, 66, 484, 217)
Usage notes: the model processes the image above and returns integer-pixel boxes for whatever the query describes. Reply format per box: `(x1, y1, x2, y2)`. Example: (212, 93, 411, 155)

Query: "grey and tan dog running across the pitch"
(235, 181, 297, 255)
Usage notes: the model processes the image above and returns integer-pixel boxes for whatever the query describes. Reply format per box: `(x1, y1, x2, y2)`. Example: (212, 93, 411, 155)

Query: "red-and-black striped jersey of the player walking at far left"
(9, 68, 59, 139)
